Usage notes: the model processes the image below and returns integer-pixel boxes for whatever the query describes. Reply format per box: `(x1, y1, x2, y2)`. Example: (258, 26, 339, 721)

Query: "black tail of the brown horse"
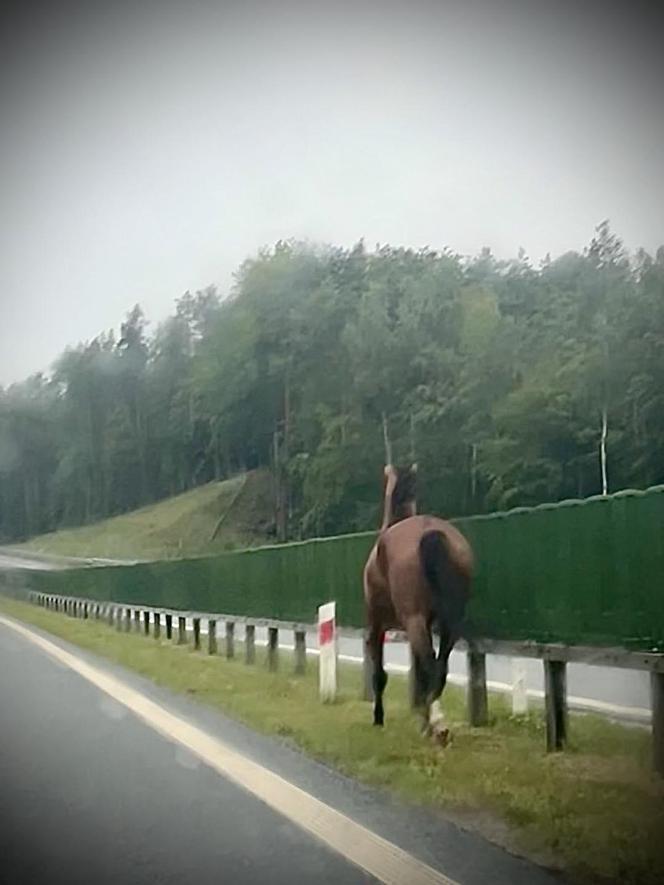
(420, 529, 469, 641)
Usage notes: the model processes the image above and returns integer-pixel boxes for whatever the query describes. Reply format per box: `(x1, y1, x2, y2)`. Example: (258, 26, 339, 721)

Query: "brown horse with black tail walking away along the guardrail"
(364, 464, 473, 745)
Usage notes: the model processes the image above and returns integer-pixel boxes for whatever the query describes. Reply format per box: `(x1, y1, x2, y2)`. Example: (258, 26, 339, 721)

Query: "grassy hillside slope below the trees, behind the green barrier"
(14, 471, 271, 559)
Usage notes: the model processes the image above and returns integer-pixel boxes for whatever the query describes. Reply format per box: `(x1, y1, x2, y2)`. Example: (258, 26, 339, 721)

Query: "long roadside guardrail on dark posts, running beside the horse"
(21, 590, 664, 776)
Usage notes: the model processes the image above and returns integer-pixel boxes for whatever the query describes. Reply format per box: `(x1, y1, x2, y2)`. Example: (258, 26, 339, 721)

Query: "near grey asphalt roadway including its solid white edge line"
(0, 617, 560, 885)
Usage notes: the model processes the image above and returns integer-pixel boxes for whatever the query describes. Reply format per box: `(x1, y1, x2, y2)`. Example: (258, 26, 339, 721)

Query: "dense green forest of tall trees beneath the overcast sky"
(0, 222, 664, 540)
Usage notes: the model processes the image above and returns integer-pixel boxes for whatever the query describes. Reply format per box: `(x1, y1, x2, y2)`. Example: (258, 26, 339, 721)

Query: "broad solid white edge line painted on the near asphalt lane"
(0, 616, 459, 885)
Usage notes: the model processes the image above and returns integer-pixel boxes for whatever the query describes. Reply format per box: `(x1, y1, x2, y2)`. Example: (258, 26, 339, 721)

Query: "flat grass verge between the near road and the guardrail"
(0, 598, 664, 885)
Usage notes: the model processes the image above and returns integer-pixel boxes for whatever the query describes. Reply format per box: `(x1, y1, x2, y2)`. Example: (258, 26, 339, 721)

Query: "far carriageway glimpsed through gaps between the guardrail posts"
(0, 549, 650, 724)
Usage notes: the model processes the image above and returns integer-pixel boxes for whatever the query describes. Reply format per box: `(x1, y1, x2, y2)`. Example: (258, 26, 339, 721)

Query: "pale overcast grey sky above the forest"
(0, 0, 664, 385)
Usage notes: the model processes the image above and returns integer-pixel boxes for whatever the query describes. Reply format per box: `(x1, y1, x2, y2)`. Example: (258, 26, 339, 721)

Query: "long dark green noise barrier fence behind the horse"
(13, 486, 664, 652)
